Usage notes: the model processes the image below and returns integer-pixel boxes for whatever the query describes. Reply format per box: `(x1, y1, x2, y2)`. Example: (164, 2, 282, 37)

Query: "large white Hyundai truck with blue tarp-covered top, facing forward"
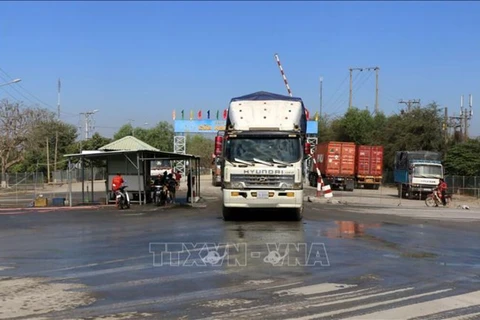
(221, 91, 310, 221)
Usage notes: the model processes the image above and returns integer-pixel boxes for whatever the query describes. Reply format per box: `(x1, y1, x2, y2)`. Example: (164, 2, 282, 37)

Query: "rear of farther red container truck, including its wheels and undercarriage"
(355, 145, 383, 189)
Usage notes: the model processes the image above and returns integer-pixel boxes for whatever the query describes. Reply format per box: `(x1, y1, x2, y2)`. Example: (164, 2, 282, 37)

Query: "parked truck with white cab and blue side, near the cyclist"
(394, 151, 443, 199)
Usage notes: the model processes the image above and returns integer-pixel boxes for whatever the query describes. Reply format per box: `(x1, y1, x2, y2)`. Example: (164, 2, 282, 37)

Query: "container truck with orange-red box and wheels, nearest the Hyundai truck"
(308, 141, 356, 191)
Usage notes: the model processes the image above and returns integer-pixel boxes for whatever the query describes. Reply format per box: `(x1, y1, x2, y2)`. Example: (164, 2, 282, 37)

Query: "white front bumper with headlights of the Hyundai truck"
(222, 189, 303, 208)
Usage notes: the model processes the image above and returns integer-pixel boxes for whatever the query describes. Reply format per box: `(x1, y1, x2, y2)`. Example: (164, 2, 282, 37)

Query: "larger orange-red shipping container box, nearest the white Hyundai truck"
(315, 141, 356, 177)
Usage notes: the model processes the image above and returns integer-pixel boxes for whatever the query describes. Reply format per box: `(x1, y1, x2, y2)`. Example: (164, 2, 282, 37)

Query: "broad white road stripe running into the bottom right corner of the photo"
(348, 291, 480, 320)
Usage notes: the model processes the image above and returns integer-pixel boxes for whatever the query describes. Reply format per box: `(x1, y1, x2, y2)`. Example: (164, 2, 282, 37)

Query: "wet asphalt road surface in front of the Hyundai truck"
(0, 197, 480, 320)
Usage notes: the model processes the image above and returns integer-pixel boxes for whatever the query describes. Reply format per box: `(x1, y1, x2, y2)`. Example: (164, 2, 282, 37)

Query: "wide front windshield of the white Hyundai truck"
(225, 137, 301, 163)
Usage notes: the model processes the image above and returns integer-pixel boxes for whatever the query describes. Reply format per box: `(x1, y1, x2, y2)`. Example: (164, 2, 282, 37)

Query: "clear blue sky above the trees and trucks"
(0, 1, 480, 136)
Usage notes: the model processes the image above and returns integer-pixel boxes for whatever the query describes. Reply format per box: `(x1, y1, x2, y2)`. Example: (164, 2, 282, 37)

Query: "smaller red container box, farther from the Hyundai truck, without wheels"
(356, 146, 383, 177)
